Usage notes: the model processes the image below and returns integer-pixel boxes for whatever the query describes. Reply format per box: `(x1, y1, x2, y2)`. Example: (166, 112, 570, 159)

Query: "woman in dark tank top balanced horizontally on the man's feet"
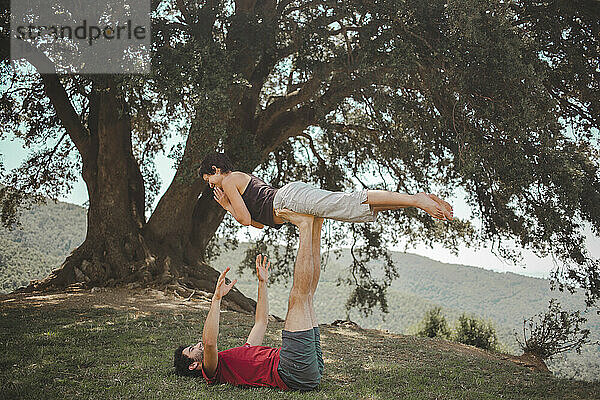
(198, 152, 452, 229)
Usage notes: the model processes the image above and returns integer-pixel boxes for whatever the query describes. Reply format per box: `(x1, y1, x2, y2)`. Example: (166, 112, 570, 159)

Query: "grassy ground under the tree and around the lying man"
(0, 289, 600, 400)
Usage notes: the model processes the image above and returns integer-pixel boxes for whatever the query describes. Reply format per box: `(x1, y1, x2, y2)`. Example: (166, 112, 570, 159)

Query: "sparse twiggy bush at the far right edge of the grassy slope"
(515, 299, 590, 360)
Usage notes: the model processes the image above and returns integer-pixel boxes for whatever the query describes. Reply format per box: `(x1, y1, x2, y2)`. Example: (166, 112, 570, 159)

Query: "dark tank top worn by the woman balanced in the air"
(242, 175, 282, 229)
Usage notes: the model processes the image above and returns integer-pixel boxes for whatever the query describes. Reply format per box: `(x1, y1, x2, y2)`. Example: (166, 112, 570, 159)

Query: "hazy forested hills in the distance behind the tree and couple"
(0, 197, 600, 379)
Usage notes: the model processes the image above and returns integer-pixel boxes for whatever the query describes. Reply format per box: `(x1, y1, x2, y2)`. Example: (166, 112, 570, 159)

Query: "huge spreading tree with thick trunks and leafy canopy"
(0, 0, 600, 309)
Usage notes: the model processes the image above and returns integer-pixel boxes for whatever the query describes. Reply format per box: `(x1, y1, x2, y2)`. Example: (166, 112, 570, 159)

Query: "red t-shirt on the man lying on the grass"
(202, 343, 289, 390)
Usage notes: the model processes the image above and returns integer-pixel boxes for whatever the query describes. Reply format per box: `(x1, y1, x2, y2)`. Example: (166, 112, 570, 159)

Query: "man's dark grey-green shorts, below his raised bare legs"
(277, 327, 324, 391)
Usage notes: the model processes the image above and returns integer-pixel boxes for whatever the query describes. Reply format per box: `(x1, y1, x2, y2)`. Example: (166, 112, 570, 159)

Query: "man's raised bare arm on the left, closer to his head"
(202, 267, 237, 377)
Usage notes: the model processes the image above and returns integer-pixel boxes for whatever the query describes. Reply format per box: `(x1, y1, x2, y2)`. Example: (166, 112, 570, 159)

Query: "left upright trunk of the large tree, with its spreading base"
(27, 87, 156, 288)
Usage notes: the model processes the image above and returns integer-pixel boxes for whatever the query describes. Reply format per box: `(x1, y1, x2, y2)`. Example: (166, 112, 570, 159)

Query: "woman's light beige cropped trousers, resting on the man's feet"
(273, 182, 377, 222)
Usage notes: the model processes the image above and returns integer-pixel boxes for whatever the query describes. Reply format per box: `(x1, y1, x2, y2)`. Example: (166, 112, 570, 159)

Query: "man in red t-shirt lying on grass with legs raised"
(174, 210, 323, 391)
